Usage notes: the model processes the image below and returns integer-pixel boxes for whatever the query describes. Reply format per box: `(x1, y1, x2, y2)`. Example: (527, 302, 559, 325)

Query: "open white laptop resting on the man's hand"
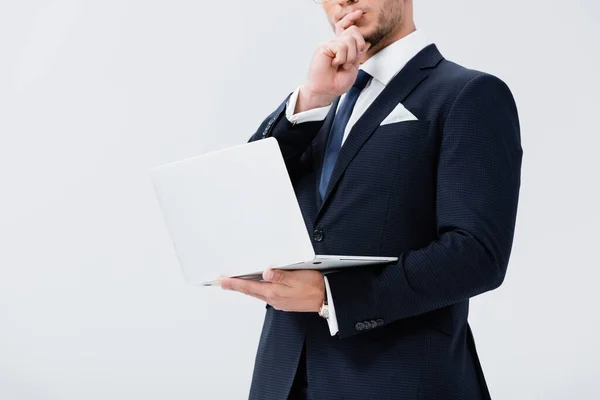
(151, 137, 398, 286)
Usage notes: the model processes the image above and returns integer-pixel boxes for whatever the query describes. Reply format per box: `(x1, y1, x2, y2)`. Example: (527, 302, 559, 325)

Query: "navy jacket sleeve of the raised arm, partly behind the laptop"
(248, 95, 324, 182)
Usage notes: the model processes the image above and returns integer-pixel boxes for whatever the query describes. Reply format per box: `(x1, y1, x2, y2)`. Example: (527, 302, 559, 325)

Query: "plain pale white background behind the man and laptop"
(0, 0, 600, 400)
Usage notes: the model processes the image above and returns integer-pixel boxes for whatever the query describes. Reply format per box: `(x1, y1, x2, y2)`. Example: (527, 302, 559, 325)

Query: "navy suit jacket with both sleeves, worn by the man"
(244, 44, 523, 400)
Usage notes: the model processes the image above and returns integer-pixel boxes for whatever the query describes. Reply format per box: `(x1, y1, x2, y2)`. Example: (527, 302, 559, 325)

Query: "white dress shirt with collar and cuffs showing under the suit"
(285, 29, 432, 336)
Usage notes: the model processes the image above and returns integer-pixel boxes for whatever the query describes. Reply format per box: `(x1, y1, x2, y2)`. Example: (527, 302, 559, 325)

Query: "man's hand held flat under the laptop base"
(219, 269, 325, 312)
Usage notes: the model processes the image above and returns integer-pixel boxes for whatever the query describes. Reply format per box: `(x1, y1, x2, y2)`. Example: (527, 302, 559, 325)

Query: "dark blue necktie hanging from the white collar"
(319, 69, 371, 199)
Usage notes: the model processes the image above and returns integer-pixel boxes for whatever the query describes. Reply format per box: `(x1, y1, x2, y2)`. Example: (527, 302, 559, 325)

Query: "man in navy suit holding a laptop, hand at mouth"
(221, 0, 522, 400)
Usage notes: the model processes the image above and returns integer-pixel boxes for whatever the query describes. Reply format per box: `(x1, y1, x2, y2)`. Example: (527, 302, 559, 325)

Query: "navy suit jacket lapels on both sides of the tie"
(316, 44, 443, 218)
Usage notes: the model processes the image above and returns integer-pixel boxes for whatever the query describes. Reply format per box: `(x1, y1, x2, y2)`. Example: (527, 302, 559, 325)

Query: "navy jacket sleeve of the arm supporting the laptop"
(328, 74, 523, 337)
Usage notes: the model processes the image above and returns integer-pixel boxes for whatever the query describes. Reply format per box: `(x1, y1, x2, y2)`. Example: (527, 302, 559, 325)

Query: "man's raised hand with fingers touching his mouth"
(294, 10, 370, 114)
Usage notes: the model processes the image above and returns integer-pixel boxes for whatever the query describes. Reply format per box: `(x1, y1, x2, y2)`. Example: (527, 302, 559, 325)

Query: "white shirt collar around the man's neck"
(360, 29, 432, 86)
